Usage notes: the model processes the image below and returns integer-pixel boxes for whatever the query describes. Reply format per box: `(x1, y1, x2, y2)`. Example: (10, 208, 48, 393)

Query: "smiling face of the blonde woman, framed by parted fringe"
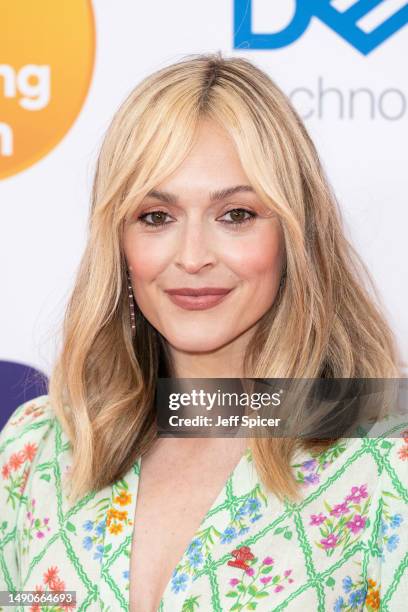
(124, 120, 284, 353)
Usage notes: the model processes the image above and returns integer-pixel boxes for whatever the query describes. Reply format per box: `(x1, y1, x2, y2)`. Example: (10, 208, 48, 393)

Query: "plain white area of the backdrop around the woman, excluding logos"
(0, 0, 408, 388)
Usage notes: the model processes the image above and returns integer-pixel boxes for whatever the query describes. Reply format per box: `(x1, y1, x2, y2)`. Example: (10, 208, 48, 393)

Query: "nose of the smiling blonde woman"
(175, 221, 216, 274)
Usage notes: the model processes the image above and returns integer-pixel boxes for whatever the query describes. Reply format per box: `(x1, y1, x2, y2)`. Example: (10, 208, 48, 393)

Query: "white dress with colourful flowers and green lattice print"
(0, 395, 408, 612)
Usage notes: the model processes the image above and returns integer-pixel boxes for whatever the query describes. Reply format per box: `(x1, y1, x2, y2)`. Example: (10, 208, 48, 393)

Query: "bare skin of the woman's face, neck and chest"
(124, 123, 284, 612)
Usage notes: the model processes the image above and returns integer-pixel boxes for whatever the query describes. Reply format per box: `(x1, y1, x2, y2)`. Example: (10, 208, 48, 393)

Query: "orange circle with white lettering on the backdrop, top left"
(0, 0, 95, 178)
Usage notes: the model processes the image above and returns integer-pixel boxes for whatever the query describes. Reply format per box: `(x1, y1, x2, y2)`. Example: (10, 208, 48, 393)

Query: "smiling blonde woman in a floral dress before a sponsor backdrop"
(0, 53, 408, 612)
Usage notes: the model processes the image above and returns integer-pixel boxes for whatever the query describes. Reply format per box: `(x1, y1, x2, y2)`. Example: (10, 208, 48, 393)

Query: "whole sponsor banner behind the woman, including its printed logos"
(0, 0, 408, 426)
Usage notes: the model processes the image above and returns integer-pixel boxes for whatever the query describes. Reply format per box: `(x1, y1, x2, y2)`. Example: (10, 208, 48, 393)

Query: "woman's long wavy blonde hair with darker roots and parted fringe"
(49, 52, 400, 499)
